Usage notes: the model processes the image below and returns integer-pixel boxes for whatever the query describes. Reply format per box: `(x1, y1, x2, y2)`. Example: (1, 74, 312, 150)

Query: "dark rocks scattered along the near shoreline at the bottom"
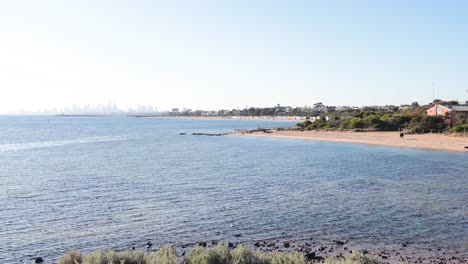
(138, 237, 468, 264)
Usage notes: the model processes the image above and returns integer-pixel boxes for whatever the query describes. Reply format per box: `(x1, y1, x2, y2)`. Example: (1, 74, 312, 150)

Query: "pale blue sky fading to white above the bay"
(0, 0, 468, 113)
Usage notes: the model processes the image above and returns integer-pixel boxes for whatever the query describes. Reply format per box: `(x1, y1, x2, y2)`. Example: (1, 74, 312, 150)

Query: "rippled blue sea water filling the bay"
(0, 117, 468, 263)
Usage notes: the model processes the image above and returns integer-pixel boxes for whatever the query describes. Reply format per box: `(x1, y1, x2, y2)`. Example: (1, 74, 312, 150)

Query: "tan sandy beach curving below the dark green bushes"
(233, 131, 468, 153)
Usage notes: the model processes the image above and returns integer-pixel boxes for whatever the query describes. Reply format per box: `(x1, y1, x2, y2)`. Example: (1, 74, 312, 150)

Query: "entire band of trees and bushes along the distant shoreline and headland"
(171, 99, 468, 133)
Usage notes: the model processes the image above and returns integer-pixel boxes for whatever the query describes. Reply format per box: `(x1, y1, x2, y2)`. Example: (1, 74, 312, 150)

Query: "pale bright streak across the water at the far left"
(0, 137, 132, 152)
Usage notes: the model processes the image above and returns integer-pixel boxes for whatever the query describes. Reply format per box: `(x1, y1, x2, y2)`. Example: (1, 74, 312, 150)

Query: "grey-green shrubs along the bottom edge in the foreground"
(58, 245, 380, 264)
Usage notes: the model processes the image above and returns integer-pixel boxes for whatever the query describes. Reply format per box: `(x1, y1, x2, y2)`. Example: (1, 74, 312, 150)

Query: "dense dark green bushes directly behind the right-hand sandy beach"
(296, 109, 468, 133)
